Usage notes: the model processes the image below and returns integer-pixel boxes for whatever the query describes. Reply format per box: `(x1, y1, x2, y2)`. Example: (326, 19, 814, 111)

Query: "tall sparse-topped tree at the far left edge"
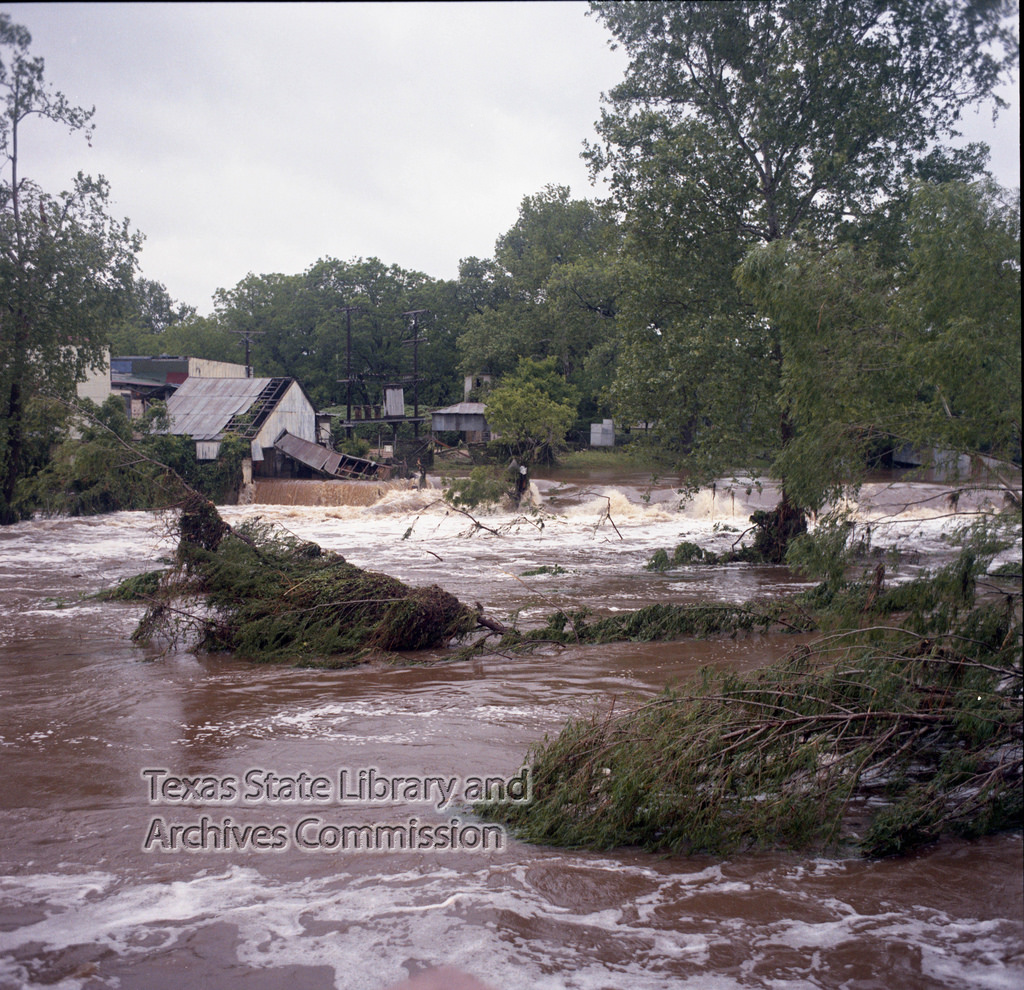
(0, 14, 139, 524)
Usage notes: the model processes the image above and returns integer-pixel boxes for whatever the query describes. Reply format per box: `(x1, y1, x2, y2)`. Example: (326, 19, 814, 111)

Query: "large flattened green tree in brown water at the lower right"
(477, 536, 1024, 855)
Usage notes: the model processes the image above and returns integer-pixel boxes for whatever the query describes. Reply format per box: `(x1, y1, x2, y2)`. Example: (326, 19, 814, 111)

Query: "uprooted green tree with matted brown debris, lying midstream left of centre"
(121, 494, 504, 666)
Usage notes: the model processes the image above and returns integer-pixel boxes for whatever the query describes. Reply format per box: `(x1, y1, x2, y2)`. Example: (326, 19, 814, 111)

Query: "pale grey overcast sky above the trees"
(0, 2, 1020, 312)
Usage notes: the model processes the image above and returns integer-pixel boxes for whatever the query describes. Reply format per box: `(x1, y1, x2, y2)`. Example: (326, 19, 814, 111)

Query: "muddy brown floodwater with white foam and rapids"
(0, 477, 1024, 990)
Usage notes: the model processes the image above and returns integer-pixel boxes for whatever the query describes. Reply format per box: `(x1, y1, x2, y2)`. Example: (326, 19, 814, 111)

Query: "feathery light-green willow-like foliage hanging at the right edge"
(737, 182, 1021, 508)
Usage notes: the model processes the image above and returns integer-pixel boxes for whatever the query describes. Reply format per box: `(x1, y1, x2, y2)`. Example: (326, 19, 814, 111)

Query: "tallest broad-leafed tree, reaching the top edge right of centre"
(587, 0, 1017, 503)
